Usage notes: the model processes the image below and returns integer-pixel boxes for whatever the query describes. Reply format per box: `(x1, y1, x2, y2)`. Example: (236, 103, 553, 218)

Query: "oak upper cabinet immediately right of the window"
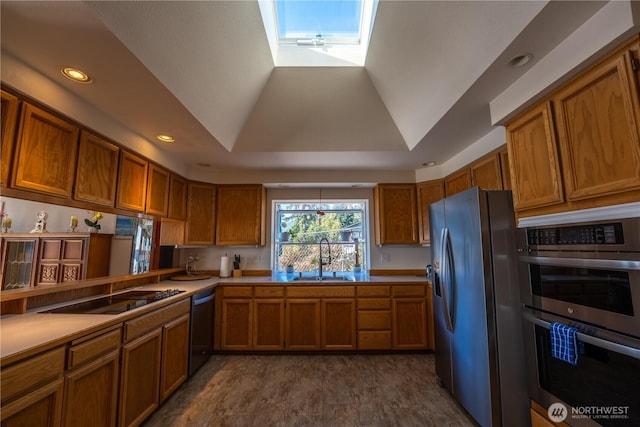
(374, 184, 418, 245)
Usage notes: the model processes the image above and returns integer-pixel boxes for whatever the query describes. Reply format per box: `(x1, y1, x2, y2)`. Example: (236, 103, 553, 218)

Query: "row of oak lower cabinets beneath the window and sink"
(216, 284, 433, 351)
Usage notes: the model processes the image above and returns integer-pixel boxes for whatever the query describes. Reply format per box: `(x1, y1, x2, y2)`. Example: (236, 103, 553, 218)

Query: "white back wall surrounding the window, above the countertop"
(180, 187, 431, 270)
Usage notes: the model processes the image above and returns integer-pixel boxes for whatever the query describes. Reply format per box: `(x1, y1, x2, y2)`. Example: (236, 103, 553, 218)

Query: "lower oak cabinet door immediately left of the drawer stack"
(321, 298, 356, 350)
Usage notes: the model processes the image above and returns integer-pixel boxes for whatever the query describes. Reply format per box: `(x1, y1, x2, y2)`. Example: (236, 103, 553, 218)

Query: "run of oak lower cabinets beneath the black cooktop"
(0, 298, 191, 427)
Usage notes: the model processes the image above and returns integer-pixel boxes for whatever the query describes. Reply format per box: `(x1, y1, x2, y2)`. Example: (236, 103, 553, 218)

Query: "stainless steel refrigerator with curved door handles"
(429, 187, 530, 426)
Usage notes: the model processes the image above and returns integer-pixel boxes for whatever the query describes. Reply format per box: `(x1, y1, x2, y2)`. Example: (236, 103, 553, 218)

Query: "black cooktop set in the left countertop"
(42, 289, 184, 314)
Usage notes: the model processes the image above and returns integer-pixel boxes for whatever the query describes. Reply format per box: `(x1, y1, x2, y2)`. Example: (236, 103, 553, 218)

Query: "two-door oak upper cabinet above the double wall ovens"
(507, 36, 640, 217)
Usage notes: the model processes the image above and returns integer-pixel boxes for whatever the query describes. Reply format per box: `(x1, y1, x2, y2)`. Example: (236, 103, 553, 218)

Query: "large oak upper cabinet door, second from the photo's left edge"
(13, 103, 79, 198)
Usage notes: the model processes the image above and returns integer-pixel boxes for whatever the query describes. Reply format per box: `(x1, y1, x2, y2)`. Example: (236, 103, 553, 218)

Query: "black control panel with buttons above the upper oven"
(527, 223, 624, 246)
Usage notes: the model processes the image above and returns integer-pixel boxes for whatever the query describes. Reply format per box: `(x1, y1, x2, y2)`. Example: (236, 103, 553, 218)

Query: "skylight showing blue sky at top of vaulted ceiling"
(259, 0, 377, 67)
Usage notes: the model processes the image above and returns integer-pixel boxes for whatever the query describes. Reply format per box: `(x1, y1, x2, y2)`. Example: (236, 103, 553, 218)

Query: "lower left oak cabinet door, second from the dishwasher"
(118, 328, 162, 427)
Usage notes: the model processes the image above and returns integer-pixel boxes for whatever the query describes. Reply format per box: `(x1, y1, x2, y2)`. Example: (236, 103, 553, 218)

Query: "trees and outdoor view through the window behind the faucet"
(273, 201, 367, 272)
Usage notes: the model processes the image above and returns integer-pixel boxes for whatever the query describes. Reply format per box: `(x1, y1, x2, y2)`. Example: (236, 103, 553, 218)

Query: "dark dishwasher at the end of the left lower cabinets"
(189, 288, 216, 376)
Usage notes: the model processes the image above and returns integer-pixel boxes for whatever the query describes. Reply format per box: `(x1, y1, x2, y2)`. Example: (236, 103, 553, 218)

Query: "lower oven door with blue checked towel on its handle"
(523, 307, 640, 426)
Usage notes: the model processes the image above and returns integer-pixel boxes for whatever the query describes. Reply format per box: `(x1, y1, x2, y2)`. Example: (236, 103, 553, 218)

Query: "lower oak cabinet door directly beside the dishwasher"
(160, 314, 189, 402)
